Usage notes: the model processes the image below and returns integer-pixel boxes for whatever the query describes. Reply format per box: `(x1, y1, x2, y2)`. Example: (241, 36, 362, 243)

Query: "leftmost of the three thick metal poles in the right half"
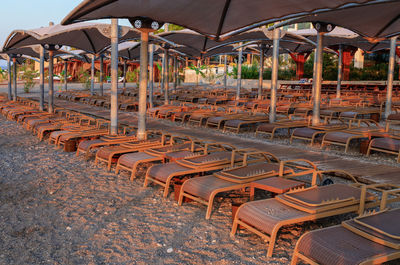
(269, 29, 281, 123)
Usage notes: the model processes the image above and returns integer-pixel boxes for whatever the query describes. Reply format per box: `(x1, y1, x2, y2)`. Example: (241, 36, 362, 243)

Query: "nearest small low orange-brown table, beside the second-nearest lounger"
(250, 177, 304, 201)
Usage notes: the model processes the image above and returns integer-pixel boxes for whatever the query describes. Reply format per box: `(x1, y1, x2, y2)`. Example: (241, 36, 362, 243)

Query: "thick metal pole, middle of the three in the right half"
(312, 32, 324, 126)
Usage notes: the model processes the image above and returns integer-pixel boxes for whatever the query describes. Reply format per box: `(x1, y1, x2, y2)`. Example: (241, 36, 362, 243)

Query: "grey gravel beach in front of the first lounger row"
(0, 114, 394, 264)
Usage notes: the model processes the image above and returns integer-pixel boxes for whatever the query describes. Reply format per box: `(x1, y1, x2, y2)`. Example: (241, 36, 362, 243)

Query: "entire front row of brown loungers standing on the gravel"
(0, 96, 400, 264)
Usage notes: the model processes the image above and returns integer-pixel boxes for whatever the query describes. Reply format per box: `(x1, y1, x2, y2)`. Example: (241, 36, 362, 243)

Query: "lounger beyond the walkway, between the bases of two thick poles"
(256, 119, 310, 140)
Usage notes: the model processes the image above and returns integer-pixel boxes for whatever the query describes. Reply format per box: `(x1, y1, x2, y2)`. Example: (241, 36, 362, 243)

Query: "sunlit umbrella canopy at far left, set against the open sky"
(3, 23, 140, 54)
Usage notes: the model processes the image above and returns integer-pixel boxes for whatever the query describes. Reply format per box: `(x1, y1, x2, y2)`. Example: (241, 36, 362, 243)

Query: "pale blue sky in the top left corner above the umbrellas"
(0, 0, 133, 67)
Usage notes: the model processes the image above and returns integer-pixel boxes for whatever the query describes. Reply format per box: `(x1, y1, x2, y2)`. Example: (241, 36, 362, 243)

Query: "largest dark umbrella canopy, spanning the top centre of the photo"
(62, 0, 376, 37)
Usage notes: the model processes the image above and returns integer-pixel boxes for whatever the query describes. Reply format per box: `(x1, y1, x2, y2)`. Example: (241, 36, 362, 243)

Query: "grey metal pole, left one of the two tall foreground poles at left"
(110, 18, 119, 135)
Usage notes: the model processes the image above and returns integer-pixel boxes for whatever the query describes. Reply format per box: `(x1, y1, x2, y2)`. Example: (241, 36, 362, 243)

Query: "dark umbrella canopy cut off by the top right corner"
(280, 0, 400, 41)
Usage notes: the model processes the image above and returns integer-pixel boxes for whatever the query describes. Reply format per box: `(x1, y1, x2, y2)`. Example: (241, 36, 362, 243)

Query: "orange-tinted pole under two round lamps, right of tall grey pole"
(137, 30, 149, 140)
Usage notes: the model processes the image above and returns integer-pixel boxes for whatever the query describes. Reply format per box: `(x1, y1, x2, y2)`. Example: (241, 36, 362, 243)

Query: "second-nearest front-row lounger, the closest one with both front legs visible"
(231, 174, 400, 257)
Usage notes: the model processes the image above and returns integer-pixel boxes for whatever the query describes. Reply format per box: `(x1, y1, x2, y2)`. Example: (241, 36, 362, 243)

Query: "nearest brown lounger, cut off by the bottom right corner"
(291, 195, 400, 265)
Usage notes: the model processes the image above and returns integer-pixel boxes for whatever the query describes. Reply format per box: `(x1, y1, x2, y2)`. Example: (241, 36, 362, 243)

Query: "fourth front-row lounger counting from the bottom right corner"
(144, 143, 252, 197)
